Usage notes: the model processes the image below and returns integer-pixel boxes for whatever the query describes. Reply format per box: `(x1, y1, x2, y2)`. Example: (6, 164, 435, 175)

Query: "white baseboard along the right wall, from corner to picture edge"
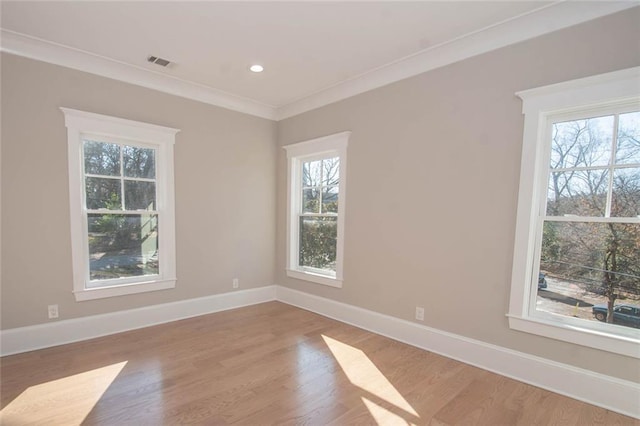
(276, 286, 640, 418)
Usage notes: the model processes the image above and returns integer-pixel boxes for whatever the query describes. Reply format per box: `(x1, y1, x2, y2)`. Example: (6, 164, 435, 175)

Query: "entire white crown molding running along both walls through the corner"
(0, 1, 638, 121)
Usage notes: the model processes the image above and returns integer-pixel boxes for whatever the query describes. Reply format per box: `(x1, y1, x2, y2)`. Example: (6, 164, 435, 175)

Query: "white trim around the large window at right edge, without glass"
(507, 67, 640, 358)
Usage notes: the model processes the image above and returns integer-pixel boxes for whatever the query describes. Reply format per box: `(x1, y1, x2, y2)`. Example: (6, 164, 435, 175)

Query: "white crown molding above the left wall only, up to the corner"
(0, 28, 276, 120)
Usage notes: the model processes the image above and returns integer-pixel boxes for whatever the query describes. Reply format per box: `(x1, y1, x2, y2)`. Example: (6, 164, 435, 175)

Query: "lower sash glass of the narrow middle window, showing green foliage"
(299, 216, 338, 272)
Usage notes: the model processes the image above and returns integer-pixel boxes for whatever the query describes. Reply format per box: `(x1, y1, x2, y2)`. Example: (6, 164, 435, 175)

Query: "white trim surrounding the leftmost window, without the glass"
(60, 108, 180, 301)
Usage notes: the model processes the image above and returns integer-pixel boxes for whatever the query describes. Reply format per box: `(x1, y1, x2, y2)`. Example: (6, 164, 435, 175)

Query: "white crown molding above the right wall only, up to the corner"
(276, 1, 638, 121)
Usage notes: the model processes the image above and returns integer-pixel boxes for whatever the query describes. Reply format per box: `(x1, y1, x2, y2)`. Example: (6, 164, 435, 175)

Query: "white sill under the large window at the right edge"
(507, 315, 640, 359)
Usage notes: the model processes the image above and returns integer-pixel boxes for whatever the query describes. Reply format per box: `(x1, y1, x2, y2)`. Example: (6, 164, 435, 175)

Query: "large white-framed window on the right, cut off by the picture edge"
(509, 68, 640, 358)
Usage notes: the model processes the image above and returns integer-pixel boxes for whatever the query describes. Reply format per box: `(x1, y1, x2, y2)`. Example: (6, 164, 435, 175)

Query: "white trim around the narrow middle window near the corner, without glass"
(283, 131, 351, 288)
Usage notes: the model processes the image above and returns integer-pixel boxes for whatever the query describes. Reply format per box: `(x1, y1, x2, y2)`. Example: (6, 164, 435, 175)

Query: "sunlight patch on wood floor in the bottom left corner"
(0, 361, 127, 425)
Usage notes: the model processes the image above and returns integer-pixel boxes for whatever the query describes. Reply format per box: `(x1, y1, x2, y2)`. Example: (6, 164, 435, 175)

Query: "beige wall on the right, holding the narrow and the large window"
(276, 8, 640, 381)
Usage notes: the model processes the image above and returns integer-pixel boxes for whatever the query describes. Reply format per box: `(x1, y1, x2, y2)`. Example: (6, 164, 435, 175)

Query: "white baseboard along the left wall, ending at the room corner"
(0, 285, 276, 356)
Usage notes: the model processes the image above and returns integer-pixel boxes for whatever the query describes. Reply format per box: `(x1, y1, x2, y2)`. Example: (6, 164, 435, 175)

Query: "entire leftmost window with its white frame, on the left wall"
(62, 108, 178, 301)
